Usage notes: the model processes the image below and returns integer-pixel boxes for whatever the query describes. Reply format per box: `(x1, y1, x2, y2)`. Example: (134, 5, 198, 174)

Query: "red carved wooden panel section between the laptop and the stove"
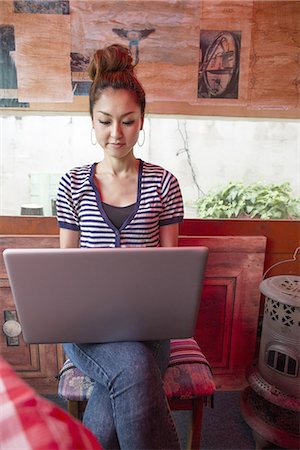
(179, 236, 266, 390)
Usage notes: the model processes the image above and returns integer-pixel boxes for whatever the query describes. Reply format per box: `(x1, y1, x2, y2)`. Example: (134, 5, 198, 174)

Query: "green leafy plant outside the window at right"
(196, 182, 300, 219)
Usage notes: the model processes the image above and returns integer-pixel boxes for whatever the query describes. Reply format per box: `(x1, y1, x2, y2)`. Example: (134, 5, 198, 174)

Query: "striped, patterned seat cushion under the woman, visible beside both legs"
(58, 338, 215, 401)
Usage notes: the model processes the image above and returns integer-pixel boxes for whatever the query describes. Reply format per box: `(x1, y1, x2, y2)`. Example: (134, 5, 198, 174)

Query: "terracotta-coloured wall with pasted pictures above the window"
(0, 0, 300, 118)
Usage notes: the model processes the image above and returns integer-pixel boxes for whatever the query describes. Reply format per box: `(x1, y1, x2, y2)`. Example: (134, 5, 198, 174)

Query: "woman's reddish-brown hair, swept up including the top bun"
(88, 44, 146, 117)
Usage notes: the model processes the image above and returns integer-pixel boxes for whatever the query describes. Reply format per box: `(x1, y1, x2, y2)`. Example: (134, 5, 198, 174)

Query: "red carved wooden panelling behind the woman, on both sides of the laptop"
(0, 235, 266, 393)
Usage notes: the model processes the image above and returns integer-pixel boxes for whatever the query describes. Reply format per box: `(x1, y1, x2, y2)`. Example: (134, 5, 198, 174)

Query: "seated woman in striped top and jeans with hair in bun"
(57, 45, 183, 450)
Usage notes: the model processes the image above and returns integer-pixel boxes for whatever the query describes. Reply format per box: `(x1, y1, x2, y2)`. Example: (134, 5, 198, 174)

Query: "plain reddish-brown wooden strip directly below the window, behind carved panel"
(0, 216, 300, 276)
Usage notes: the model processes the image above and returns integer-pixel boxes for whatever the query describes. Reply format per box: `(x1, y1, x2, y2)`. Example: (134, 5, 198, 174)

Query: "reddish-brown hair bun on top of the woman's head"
(88, 44, 133, 81)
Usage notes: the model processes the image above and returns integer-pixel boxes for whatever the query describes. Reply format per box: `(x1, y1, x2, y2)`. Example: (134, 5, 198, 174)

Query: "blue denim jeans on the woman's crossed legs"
(64, 341, 180, 450)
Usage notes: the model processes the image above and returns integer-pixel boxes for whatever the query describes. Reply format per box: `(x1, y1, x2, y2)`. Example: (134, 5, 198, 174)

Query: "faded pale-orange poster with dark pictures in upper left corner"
(0, 0, 73, 108)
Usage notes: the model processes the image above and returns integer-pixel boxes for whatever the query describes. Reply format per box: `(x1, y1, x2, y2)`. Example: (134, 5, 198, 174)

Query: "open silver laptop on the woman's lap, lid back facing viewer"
(3, 247, 208, 343)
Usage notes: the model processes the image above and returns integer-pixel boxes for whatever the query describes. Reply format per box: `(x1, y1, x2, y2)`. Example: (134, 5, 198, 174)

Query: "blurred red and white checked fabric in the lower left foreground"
(0, 357, 102, 450)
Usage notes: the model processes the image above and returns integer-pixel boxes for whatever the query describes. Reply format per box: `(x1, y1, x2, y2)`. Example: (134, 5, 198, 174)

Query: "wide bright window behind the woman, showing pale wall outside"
(0, 113, 300, 218)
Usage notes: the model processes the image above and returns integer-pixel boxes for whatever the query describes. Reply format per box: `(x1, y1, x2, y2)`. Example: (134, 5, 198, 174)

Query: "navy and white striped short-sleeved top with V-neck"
(56, 160, 183, 247)
